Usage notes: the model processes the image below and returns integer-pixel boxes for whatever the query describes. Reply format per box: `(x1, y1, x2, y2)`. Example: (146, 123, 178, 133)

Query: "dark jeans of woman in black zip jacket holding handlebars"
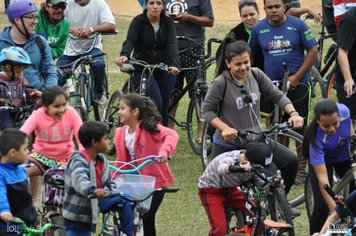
(134, 71, 176, 126)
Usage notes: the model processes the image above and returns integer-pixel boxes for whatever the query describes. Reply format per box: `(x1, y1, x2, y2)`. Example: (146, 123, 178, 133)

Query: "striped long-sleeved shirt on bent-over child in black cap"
(198, 150, 259, 189)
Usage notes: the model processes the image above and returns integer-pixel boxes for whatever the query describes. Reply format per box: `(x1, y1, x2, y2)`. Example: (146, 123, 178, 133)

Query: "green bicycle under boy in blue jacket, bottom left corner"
(0, 217, 64, 236)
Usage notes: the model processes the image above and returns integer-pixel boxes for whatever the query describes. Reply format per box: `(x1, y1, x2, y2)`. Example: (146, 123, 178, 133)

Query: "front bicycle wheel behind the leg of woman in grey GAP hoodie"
(267, 130, 309, 207)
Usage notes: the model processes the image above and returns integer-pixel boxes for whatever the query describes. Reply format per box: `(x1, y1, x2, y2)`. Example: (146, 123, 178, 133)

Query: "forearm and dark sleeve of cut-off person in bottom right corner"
(313, 190, 356, 236)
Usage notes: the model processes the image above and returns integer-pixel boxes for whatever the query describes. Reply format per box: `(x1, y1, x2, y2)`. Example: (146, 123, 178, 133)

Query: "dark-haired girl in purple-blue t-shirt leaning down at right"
(303, 99, 354, 235)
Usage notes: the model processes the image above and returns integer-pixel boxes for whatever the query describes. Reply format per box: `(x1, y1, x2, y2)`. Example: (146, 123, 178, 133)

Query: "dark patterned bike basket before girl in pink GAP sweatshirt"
(42, 167, 64, 207)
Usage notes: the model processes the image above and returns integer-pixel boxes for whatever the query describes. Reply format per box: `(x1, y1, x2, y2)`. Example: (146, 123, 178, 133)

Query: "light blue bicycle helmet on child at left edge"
(0, 46, 31, 65)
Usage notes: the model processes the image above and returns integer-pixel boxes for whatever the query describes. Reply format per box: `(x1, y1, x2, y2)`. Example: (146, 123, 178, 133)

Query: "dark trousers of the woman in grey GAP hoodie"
(212, 140, 298, 194)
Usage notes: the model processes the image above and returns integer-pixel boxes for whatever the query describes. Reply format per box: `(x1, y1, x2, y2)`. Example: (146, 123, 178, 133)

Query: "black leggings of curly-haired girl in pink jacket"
(143, 191, 164, 236)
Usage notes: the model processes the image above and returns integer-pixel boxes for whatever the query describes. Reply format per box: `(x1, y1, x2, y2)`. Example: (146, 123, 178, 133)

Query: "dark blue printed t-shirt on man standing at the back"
(249, 16, 316, 83)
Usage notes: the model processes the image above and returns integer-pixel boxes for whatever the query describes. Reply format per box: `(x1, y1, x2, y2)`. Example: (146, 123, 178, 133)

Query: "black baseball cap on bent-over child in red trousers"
(245, 142, 273, 166)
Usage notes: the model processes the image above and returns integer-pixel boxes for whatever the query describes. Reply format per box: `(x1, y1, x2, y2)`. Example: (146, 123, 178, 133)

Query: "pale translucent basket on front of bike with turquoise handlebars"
(113, 174, 156, 213)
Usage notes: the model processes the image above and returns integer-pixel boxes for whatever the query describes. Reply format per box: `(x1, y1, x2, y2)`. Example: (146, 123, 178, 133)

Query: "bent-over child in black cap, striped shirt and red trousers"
(198, 142, 273, 236)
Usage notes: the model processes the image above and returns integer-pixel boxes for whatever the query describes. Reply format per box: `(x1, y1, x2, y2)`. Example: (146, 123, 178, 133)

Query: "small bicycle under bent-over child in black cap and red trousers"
(226, 165, 294, 236)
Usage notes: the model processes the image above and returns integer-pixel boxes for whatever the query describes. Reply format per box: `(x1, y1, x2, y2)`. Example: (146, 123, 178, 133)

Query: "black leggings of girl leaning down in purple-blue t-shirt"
(309, 160, 354, 235)
